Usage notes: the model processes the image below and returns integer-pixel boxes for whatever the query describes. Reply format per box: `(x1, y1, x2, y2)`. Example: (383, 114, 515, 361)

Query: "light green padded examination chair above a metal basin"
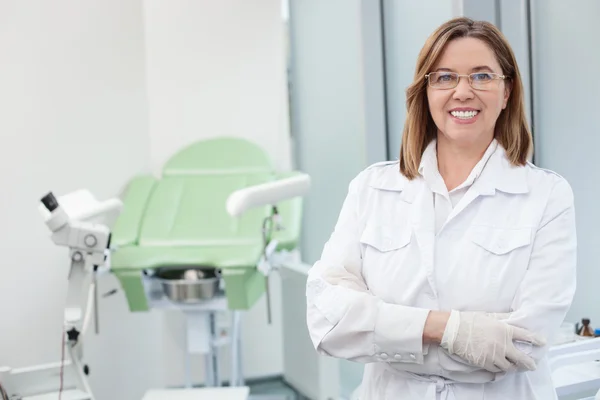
(110, 138, 302, 312)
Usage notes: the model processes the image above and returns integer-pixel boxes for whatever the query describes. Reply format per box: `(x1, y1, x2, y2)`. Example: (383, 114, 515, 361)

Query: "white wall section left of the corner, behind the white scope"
(0, 0, 157, 398)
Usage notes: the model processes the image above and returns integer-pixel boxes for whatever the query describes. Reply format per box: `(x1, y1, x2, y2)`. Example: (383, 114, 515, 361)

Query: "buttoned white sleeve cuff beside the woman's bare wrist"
(374, 302, 429, 364)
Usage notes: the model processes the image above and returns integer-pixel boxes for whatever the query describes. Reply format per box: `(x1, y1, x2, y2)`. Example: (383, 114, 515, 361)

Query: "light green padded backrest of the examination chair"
(139, 138, 277, 247)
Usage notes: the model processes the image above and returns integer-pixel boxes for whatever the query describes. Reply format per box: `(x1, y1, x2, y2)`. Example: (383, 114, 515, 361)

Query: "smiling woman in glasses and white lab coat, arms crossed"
(307, 18, 576, 400)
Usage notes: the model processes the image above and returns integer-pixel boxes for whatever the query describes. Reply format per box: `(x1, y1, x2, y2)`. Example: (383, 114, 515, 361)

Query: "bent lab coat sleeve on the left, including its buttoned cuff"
(306, 175, 429, 364)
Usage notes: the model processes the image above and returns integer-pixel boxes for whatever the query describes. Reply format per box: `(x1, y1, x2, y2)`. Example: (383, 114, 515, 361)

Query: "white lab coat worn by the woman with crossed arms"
(306, 142, 576, 400)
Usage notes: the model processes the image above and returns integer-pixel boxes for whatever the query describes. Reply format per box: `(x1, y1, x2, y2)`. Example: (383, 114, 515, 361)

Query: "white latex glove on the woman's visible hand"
(440, 311, 545, 373)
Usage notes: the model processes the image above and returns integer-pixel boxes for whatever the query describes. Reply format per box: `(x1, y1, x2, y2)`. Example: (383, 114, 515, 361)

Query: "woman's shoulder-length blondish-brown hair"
(400, 17, 533, 179)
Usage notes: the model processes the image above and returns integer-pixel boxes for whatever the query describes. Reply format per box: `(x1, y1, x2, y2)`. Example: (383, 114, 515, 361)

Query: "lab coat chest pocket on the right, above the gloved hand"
(466, 226, 532, 305)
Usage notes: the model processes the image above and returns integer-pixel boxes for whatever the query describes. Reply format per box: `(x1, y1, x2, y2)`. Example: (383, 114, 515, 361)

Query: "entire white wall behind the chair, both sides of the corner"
(0, 0, 291, 400)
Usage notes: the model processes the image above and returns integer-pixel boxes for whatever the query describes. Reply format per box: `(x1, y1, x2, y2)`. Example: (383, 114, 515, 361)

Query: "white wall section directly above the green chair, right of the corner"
(145, 0, 290, 172)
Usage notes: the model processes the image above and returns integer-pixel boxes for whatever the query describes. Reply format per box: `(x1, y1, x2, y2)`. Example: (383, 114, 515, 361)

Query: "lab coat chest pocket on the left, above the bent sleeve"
(360, 224, 415, 297)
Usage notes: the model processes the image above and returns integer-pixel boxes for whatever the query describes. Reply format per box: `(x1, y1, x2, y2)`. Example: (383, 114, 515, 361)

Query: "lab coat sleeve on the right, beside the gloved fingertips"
(508, 179, 577, 360)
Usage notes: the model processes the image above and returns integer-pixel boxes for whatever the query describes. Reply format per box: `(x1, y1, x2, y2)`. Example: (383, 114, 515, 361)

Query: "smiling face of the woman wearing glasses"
(427, 37, 510, 147)
